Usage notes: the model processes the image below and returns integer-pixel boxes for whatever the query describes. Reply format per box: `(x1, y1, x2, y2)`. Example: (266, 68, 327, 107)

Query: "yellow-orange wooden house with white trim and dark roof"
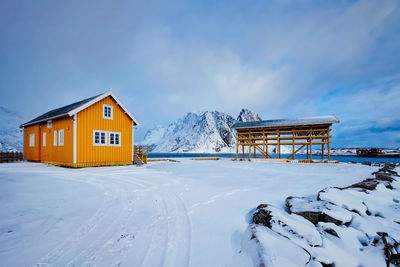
(20, 91, 139, 167)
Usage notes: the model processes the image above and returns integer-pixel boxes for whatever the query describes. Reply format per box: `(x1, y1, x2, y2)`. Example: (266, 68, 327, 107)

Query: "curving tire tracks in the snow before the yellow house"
(32, 169, 191, 266)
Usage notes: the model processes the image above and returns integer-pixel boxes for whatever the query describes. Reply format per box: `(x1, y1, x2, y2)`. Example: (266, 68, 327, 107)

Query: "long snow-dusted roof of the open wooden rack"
(232, 116, 340, 129)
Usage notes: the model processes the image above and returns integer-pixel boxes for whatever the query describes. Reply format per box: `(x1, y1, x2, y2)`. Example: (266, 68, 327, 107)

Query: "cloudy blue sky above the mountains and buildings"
(0, 0, 400, 147)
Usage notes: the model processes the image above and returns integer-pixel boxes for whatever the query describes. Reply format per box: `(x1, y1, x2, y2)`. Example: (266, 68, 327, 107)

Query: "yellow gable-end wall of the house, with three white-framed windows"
(77, 96, 133, 163)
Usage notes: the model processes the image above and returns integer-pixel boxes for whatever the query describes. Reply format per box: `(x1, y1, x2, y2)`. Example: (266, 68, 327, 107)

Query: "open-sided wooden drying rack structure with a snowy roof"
(232, 116, 340, 160)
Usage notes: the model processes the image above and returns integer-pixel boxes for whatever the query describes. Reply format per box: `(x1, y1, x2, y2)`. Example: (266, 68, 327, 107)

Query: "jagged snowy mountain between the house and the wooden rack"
(141, 109, 261, 153)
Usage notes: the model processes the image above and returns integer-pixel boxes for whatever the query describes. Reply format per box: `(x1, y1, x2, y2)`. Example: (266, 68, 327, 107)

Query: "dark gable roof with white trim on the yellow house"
(20, 90, 139, 127)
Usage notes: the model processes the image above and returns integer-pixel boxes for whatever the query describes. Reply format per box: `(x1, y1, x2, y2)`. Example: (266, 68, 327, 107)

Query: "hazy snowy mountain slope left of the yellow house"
(0, 106, 23, 151)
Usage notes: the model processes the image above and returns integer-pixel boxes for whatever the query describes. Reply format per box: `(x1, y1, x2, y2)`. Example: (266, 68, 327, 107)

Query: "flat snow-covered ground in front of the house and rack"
(0, 159, 378, 266)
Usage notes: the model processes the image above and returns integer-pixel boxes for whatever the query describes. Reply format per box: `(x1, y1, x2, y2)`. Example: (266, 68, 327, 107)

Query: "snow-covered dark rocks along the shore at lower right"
(244, 163, 400, 266)
